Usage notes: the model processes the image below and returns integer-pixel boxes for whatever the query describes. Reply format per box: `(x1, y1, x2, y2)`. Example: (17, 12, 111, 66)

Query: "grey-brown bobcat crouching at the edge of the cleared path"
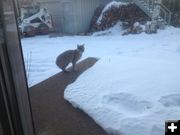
(56, 44, 85, 72)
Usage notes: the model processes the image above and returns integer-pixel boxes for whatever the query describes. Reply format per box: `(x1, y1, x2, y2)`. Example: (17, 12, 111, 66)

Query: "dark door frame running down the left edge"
(0, 0, 35, 135)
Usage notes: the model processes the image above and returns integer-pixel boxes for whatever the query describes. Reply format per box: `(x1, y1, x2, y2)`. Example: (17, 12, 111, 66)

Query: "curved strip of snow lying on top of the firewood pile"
(97, 1, 129, 24)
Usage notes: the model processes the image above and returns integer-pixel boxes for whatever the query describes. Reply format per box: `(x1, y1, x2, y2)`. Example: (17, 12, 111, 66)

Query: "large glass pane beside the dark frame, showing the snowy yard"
(15, 0, 180, 135)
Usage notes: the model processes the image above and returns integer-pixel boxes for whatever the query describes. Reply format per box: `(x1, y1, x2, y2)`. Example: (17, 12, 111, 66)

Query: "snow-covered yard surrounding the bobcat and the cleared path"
(22, 25, 180, 135)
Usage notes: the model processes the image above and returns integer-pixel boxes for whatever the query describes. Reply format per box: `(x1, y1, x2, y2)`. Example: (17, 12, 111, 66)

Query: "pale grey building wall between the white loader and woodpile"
(34, 0, 111, 34)
